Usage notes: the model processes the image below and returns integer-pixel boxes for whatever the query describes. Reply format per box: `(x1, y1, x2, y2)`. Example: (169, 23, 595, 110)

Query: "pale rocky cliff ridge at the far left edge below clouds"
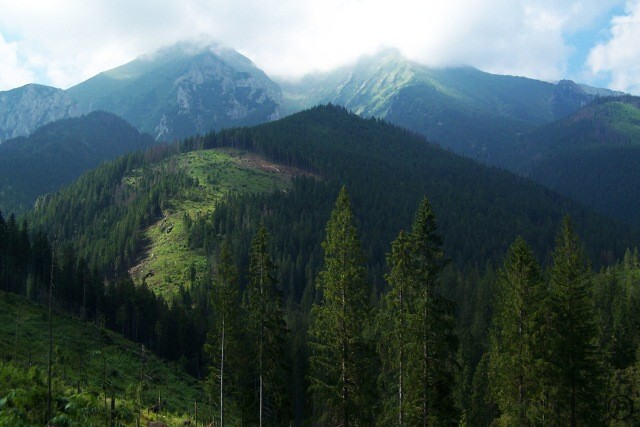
(0, 84, 81, 143)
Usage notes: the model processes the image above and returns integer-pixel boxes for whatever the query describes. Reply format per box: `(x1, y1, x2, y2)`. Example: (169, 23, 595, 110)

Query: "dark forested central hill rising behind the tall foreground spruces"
(29, 106, 640, 299)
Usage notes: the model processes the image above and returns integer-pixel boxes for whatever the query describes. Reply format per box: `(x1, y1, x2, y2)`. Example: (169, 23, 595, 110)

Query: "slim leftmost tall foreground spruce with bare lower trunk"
(205, 242, 239, 425)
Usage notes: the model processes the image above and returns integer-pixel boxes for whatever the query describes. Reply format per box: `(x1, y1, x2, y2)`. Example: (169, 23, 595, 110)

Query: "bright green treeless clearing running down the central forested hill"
(131, 149, 290, 295)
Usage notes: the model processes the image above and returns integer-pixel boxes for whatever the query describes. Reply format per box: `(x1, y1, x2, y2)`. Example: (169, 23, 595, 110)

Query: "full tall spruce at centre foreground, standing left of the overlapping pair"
(309, 187, 374, 427)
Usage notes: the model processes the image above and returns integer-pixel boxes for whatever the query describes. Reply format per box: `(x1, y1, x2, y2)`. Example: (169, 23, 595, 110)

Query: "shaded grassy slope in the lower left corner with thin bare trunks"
(0, 292, 204, 425)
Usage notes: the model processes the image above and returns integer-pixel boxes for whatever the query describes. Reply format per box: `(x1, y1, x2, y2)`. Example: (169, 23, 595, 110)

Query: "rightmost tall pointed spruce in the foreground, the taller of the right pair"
(546, 217, 604, 426)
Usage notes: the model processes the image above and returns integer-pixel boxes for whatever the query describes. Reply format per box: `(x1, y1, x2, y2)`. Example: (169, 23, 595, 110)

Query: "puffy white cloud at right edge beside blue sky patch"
(588, 1, 640, 95)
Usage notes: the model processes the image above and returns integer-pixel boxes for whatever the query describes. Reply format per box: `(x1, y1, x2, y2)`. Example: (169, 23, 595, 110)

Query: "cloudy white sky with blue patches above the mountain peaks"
(0, 0, 640, 95)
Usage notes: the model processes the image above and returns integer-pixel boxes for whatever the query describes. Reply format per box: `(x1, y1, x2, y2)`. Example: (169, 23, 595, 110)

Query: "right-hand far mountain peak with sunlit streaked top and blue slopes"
(281, 50, 616, 164)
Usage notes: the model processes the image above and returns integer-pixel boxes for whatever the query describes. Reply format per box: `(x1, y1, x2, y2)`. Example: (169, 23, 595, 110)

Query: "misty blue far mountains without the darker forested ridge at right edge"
(0, 42, 622, 147)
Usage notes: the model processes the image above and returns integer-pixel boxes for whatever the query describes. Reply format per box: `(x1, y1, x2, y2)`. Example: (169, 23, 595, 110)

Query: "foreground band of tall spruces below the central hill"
(0, 196, 640, 425)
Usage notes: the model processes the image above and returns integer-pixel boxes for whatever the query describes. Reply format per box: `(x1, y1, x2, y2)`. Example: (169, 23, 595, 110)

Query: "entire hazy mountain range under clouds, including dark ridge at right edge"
(0, 42, 640, 225)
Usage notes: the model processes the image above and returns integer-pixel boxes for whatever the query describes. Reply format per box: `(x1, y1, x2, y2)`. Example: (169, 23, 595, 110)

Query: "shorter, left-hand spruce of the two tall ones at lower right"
(489, 237, 546, 425)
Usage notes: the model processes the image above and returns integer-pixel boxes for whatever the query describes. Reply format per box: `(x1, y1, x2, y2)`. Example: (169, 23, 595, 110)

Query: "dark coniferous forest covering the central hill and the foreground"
(0, 106, 640, 426)
